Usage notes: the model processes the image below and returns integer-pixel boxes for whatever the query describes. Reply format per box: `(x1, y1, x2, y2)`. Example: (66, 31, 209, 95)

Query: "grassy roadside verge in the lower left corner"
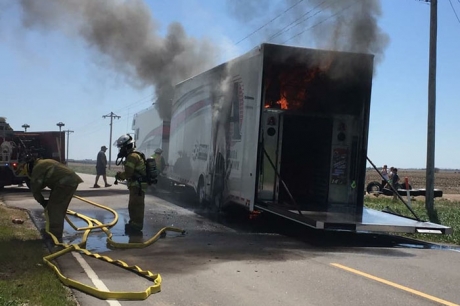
(0, 201, 77, 306)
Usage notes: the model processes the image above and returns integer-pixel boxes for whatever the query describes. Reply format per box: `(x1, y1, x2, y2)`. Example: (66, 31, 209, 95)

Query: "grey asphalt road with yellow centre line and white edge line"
(0, 174, 460, 306)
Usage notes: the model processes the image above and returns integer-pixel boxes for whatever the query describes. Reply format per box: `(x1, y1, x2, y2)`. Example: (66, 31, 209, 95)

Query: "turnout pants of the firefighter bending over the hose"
(46, 185, 78, 239)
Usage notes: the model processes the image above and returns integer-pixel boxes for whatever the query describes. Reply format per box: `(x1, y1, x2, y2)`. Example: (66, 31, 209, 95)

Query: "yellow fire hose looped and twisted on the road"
(43, 195, 185, 300)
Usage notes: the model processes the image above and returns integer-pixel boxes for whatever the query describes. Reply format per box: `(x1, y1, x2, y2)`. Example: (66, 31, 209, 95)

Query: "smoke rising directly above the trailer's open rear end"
(227, 0, 390, 64)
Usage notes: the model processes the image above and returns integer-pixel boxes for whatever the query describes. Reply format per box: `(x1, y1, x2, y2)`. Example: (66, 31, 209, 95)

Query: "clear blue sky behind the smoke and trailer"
(0, 0, 460, 168)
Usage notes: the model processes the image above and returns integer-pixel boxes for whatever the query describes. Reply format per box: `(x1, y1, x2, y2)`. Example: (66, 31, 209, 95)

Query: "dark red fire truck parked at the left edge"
(0, 117, 65, 189)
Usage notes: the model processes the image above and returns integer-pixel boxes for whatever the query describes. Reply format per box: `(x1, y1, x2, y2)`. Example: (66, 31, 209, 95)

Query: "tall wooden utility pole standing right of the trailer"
(425, 0, 438, 213)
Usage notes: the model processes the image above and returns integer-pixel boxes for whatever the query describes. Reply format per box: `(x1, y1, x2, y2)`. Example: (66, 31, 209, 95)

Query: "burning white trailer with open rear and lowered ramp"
(133, 44, 452, 234)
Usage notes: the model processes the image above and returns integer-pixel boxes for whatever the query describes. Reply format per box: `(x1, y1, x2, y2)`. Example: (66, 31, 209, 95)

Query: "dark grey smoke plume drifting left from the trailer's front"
(15, 0, 217, 119)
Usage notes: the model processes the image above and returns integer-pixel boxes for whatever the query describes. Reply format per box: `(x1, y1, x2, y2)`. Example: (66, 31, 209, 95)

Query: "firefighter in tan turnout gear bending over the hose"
(25, 158, 83, 242)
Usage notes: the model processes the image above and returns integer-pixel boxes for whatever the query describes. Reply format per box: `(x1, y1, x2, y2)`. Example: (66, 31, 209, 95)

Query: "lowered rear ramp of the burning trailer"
(256, 204, 452, 234)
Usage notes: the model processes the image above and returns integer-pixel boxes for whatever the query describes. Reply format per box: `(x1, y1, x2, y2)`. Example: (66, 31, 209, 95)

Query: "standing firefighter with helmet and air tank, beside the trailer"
(115, 134, 147, 234)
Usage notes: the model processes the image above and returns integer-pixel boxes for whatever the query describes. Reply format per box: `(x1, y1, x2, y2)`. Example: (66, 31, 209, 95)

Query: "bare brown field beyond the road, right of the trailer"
(366, 169, 460, 200)
